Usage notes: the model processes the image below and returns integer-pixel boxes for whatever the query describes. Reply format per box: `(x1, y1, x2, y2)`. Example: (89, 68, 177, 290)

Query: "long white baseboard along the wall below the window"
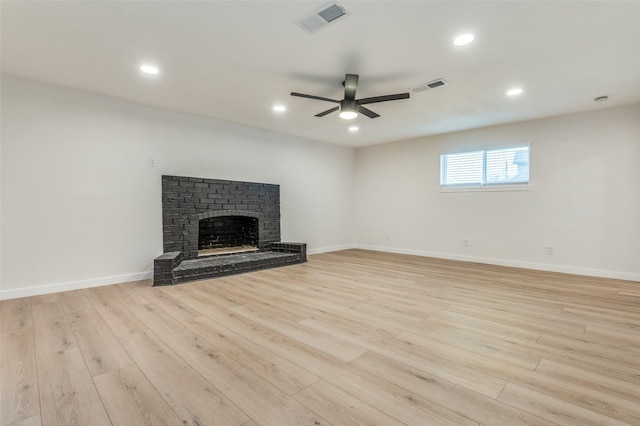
(355, 244, 640, 282)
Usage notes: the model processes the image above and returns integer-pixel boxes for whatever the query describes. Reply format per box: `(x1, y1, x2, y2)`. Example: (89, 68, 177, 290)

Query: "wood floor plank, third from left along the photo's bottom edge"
(93, 365, 182, 426)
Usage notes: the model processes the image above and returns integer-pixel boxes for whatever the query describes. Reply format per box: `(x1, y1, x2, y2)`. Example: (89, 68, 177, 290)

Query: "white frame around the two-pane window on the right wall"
(438, 142, 533, 192)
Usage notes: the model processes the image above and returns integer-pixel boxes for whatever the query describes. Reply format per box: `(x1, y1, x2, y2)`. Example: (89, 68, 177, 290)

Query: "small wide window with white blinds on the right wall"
(440, 145, 530, 188)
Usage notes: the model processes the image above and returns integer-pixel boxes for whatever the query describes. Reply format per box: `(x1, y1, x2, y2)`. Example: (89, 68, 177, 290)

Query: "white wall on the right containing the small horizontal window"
(355, 105, 640, 281)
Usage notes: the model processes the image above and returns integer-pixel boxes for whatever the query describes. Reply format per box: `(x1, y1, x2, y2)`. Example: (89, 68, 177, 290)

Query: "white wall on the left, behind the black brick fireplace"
(0, 76, 355, 298)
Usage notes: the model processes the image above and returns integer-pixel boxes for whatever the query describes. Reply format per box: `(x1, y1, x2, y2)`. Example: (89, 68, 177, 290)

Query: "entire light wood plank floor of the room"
(0, 250, 640, 426)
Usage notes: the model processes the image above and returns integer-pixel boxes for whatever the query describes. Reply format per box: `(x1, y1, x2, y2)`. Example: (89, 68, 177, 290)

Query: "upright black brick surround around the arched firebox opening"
(162, 176, 280, 259)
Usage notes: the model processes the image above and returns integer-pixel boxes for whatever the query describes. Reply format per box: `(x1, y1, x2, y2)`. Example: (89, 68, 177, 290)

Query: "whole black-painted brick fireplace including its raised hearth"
(154, 176, 306, 285)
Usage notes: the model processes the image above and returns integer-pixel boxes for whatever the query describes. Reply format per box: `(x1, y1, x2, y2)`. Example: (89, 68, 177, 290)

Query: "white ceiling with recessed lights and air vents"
(1, 0, 640, 146)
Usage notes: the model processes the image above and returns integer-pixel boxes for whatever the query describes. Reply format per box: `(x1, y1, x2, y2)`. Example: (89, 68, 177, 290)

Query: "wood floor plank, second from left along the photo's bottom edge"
(37, 348, 111, 426)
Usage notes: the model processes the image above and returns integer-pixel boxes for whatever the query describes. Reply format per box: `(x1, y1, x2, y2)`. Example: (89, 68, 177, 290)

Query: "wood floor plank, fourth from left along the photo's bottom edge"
(120, 332, 249, 426)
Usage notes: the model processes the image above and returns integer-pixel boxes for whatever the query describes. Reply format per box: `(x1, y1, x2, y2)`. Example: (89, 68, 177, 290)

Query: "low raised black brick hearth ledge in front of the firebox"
(153, 242, 307, 286)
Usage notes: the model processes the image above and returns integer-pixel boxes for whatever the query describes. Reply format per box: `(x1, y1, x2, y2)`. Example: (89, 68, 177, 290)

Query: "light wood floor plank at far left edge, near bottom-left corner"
(0, 328, 40, 425)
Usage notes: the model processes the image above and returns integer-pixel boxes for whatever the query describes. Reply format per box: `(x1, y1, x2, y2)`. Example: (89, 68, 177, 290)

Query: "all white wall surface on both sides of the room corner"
(0, 76, 640, 298)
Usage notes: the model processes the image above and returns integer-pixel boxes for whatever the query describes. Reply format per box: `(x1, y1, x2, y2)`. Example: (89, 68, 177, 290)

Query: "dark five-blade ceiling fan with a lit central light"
(291, 74, 409, 120)
